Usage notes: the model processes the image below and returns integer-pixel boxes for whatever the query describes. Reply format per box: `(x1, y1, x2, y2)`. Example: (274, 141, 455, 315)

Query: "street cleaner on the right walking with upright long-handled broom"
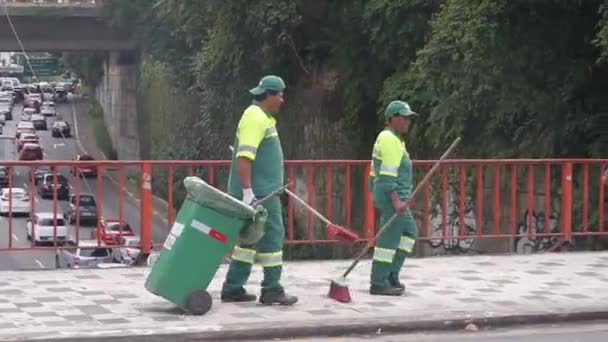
(370, 101, 418, 296)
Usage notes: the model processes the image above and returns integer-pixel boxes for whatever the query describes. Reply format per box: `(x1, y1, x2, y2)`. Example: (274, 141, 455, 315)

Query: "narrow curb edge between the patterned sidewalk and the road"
(39, 311, 608, 342)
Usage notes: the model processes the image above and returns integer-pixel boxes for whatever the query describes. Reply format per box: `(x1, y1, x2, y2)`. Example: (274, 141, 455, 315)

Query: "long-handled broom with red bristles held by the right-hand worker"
(328, 138, 460, 303)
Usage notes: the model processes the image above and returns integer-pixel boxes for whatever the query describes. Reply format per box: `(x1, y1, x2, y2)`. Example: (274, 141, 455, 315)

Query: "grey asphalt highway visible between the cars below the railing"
(0, 95, 168, 270)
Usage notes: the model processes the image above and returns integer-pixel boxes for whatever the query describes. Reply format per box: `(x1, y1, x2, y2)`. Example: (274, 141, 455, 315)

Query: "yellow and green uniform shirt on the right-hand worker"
(370, 128, 413, 203)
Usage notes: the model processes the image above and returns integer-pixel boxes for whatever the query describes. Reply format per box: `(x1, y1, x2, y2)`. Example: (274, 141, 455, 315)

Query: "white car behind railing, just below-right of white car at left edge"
(26, 212, 69, 245)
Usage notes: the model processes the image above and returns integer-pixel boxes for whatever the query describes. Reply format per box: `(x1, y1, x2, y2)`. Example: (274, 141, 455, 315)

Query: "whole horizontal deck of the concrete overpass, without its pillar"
(0, 0, 136, 51)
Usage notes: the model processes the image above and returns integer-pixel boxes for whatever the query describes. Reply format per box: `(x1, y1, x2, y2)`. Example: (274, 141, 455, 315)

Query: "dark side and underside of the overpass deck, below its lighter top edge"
(0, 17, 136, 51)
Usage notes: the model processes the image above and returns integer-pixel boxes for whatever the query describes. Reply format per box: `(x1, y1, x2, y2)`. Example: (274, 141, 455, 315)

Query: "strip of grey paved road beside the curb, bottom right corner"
(280, 322, 608, 342)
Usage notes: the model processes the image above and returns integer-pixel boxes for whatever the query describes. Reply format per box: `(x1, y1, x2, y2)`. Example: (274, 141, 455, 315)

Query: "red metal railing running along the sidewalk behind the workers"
(0, 159, 608, 253)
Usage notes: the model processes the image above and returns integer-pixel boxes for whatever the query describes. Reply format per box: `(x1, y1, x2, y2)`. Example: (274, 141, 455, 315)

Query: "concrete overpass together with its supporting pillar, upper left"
(0, 0, 140, 160)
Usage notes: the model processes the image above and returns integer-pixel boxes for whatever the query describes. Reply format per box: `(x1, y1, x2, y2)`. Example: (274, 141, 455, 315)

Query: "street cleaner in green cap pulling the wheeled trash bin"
(221, 75, 298, 305)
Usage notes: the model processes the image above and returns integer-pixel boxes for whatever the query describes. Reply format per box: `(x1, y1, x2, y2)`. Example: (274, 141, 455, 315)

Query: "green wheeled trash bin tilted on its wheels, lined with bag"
(145, 177, 268, 315)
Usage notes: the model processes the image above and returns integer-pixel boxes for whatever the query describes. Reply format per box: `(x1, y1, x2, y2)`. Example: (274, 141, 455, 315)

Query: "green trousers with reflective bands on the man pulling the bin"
(222, 196, 285, 294)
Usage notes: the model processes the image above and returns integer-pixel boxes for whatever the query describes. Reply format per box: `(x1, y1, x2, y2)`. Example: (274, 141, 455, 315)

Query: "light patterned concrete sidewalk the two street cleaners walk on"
(0, 252, 608, 341)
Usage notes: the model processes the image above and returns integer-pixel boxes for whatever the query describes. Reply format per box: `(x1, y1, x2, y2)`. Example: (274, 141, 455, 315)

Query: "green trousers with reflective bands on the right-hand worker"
(370, 201, 418, 287)
